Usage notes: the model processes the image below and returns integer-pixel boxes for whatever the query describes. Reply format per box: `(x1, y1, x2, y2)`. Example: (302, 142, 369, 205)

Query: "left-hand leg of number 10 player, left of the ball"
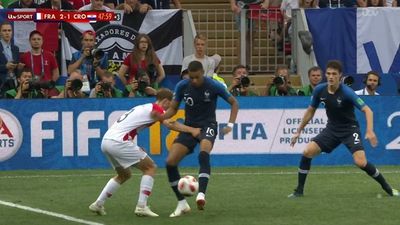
(166, 136, 194, 217)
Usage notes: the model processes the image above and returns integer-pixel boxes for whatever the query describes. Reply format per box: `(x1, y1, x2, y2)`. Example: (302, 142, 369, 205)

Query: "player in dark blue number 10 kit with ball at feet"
(161, 61, 239, 217)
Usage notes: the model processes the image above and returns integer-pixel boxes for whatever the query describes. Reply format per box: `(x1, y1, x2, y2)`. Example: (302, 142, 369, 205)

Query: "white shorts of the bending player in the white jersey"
(101, 139, 147, 169)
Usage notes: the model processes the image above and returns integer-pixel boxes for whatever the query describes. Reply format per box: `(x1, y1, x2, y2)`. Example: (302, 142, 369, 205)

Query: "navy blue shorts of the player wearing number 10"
(174, 123, 218, 154)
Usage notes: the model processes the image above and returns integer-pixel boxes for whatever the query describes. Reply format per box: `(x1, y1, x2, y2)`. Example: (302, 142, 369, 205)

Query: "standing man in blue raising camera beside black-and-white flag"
(68, 30, 108, 92)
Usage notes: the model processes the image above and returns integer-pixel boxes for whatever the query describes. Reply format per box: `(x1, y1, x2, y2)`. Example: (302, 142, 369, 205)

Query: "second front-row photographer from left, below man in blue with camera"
(54, 70, 86, 98)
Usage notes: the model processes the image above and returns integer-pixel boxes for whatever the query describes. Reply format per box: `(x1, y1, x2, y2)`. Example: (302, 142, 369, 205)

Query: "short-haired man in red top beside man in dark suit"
(21, 30, 60, 82)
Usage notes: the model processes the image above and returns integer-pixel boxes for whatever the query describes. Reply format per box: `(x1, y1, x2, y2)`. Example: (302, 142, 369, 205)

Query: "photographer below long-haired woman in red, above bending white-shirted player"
(124, 70, 157, 97)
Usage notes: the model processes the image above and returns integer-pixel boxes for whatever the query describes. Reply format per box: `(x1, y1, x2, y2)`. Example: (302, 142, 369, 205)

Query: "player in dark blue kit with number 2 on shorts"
(288, 60, 399, 197)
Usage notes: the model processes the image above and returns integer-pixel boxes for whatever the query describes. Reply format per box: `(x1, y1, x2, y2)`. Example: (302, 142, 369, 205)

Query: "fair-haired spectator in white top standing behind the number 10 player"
(181, 34, 215, 77)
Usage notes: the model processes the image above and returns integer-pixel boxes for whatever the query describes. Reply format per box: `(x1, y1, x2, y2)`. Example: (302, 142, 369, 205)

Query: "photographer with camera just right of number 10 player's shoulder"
(228, 65, 258, 96)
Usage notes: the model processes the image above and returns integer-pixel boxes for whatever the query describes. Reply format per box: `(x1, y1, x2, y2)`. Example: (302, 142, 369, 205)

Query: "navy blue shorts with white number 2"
(312, 126, 364, 154)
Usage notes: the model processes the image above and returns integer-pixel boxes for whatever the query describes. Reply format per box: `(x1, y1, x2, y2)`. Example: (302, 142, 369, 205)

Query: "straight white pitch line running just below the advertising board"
(0, 169, 400, 180)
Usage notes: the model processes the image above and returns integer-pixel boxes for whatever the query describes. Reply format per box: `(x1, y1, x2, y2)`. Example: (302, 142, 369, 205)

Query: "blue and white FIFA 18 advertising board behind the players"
(0, 96, 400, 170)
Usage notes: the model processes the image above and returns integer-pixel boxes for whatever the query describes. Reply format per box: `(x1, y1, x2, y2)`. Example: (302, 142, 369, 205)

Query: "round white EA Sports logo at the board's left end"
(0, 109, 23, 162)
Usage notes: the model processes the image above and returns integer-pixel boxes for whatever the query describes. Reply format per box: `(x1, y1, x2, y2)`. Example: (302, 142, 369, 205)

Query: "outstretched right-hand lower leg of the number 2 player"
(353, 150, 399, 196)
